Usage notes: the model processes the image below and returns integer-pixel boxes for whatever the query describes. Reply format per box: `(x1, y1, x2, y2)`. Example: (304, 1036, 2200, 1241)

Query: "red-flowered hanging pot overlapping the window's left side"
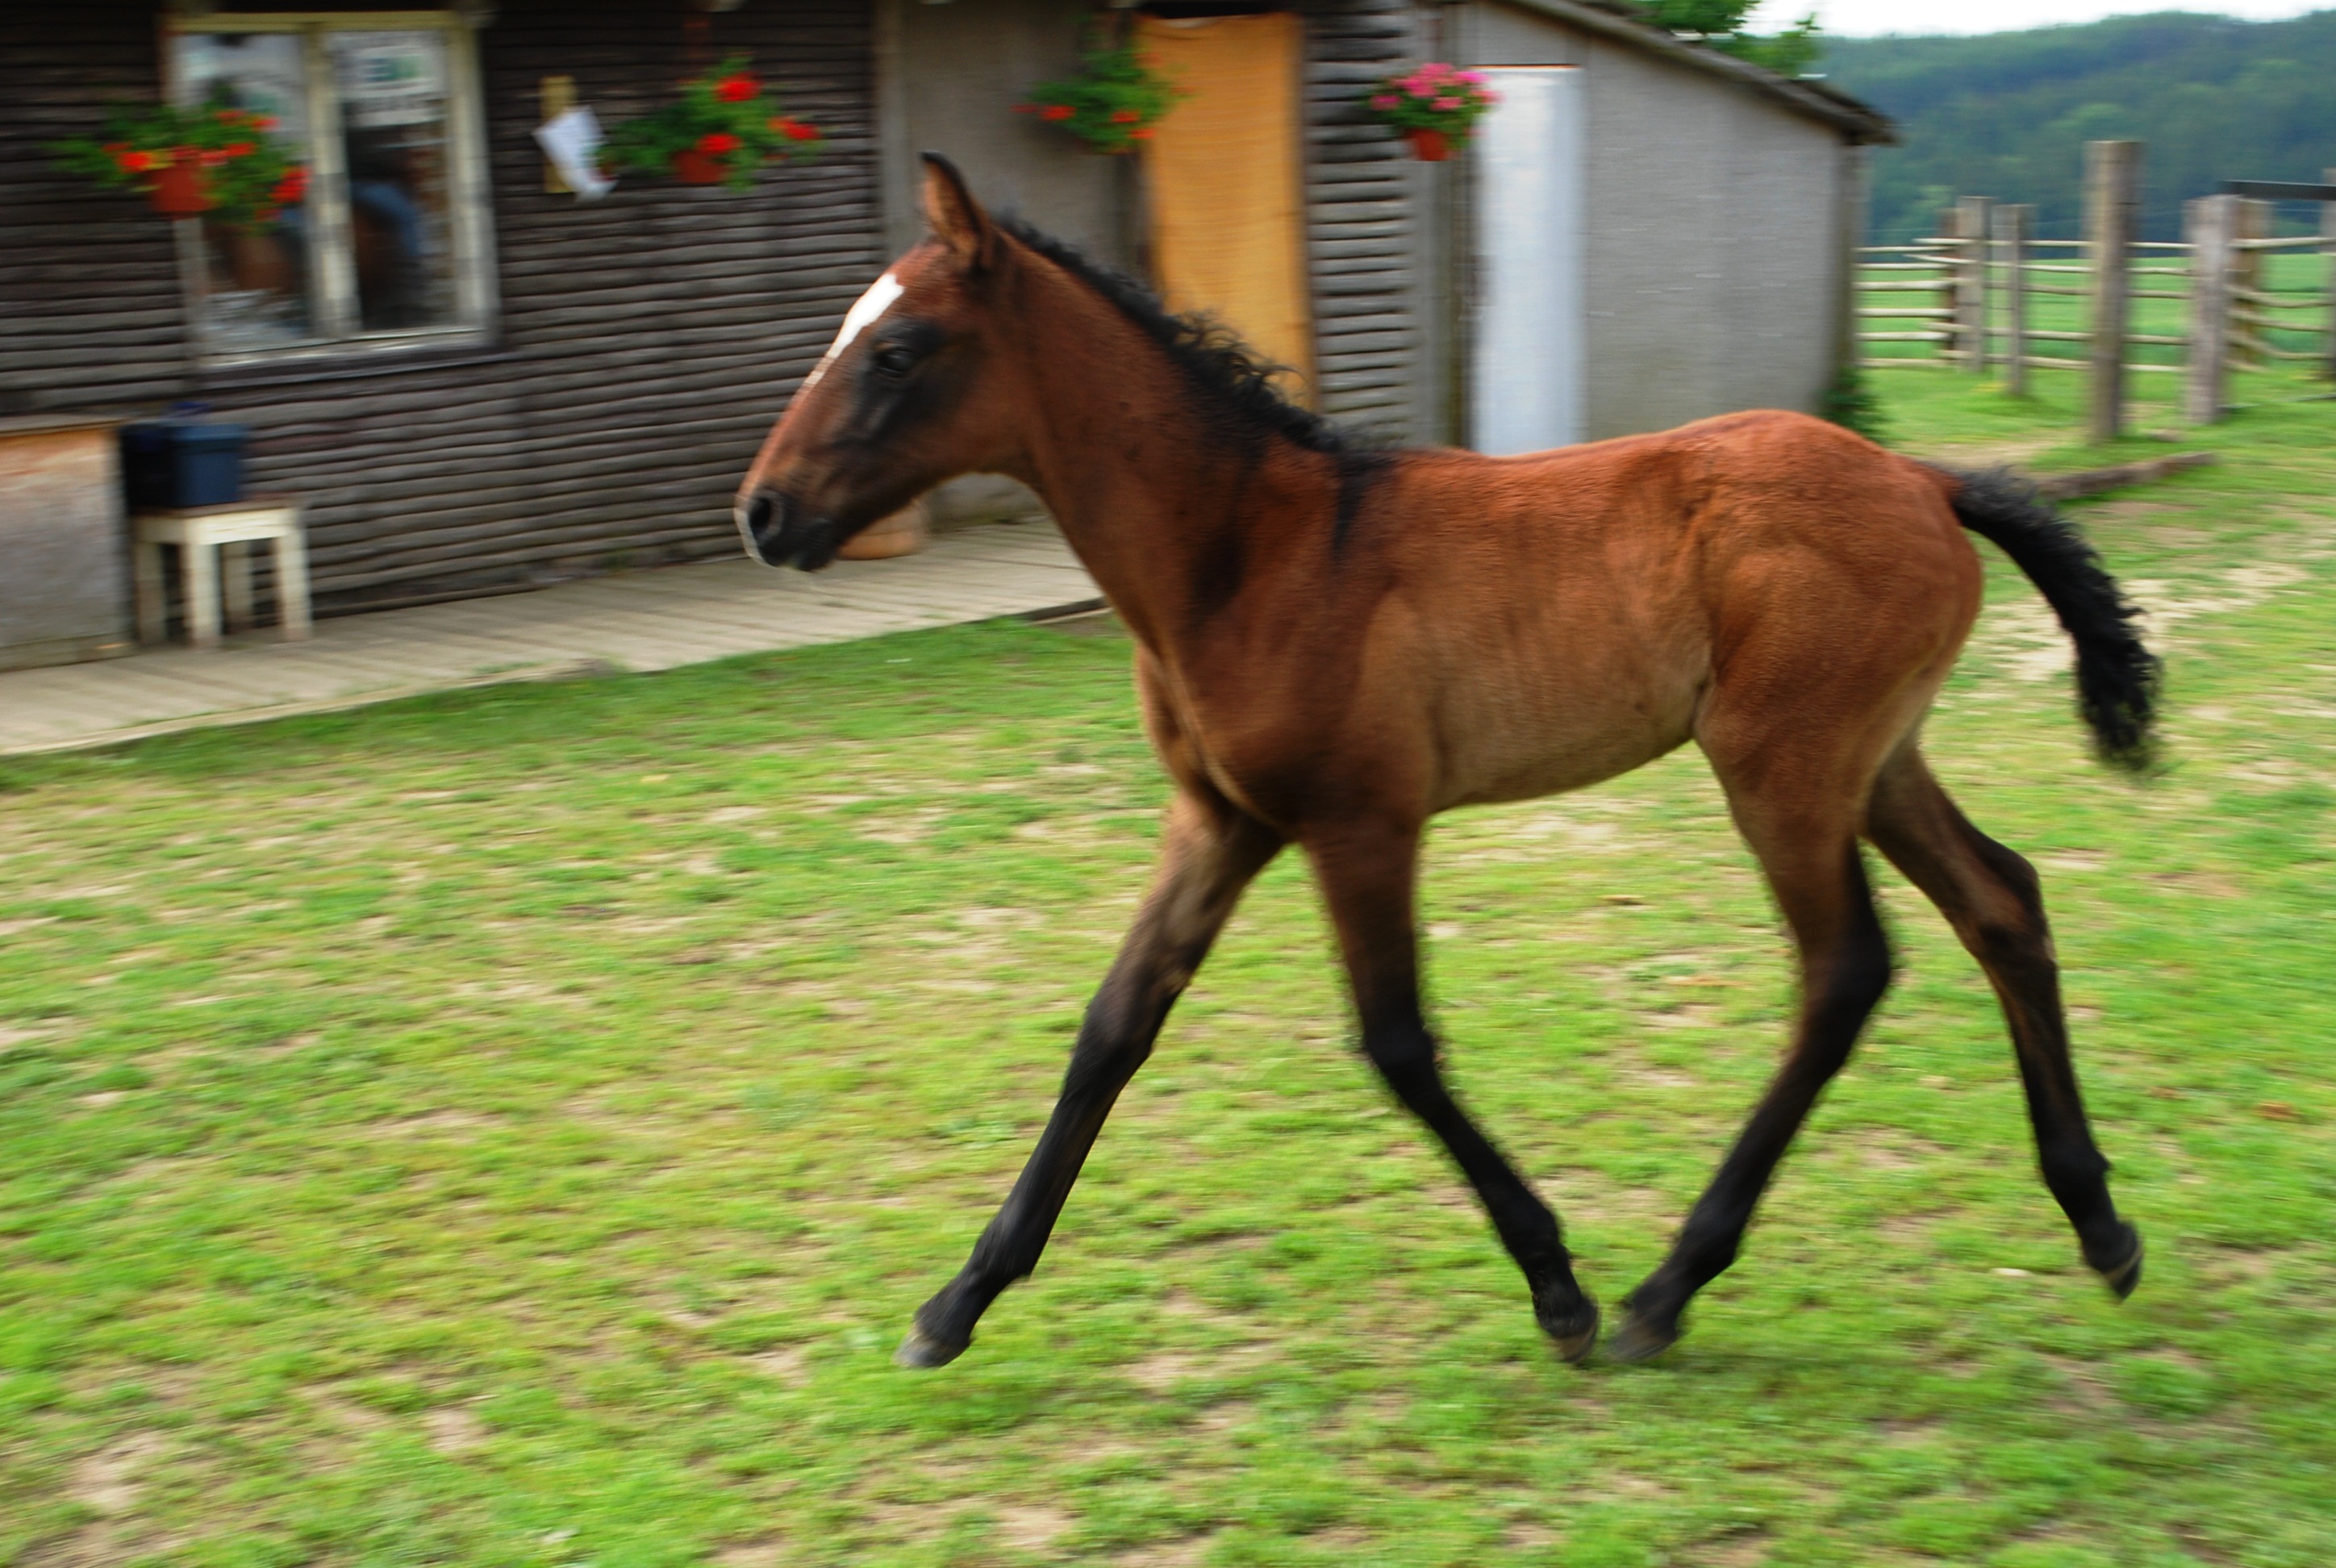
(49, 98, 308, 234)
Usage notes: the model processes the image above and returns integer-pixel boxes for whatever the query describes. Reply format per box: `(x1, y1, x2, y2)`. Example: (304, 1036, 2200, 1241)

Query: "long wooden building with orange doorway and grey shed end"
(0, 0, 1888, 643)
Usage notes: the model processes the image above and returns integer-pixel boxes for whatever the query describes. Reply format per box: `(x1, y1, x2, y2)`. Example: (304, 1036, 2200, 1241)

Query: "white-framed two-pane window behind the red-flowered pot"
(169, 11, 493, 362)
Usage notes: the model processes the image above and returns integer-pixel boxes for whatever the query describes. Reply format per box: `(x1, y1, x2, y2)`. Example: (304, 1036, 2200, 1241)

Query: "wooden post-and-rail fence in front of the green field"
(1854, 143, 2336, 440)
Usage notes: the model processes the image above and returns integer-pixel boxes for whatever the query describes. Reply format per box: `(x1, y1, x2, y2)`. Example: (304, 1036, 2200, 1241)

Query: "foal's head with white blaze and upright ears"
(736, 152, 1023, 573)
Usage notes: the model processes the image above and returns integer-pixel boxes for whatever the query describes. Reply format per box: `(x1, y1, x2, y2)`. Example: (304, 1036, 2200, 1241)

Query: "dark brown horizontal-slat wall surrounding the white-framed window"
(0, 0, 886, 612)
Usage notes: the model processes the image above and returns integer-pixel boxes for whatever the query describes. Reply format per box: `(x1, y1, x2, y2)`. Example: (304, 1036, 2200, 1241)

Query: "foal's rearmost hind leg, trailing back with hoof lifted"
(1867, 745, 2142, 1297)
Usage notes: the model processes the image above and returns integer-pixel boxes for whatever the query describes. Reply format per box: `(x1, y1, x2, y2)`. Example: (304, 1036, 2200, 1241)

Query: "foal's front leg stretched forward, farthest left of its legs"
(895, 792, 1283, 1367)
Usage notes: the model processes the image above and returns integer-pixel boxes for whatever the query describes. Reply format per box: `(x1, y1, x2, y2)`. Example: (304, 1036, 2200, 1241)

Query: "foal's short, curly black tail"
(1939, 467, 2159, 774)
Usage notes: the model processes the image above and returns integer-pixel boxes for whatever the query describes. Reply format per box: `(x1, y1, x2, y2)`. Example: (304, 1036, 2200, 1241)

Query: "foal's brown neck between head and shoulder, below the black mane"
(1025, 261, 1338, 666)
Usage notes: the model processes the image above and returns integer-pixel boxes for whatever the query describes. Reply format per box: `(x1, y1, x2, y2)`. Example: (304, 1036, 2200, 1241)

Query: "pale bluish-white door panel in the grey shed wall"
(1470, 65, 1583, 453)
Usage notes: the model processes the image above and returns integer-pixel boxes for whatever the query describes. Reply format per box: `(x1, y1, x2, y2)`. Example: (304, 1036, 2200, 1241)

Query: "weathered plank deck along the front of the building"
(0, 523, 1098, 755)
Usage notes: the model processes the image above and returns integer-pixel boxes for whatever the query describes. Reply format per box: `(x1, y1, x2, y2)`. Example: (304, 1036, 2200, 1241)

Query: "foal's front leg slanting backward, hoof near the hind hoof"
(1306, 823, 1598, 1360)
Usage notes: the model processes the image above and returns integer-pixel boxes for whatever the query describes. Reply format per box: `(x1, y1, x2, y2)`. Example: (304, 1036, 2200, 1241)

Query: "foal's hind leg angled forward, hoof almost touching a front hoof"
(1607, 799, 1890, 1360)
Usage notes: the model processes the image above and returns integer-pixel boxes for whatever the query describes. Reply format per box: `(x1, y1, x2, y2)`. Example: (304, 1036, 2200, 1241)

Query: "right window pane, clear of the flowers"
(327, 33, 458, 332)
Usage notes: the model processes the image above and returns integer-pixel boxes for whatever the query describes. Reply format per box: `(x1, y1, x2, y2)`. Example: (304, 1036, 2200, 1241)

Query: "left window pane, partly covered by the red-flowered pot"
(173, 33, 315, 351)
